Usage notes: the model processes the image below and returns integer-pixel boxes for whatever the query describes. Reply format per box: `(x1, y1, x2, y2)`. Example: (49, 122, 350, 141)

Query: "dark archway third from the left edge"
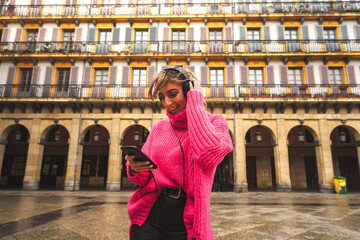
(80, 125, 110, 189)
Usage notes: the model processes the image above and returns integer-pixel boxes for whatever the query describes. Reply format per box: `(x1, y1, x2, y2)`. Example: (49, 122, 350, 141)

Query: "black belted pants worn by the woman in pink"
(130, 191, 187, 240)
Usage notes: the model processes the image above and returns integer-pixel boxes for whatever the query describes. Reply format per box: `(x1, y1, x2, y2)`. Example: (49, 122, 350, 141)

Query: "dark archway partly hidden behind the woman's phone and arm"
(121, 124, 149, 189)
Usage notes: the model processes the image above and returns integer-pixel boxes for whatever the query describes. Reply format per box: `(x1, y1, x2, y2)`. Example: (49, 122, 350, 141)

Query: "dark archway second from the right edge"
(287, 125, 319, 190)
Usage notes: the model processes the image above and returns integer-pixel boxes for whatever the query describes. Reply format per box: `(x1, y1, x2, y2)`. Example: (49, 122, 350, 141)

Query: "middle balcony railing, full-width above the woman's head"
(0, 39, 360, 55)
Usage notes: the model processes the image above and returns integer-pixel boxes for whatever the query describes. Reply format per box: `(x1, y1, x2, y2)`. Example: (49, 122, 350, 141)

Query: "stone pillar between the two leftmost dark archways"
(23, 118, 44, 190)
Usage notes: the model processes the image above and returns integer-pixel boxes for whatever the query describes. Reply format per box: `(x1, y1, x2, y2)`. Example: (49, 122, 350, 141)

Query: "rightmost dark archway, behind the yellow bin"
(330, 126, 360, 191)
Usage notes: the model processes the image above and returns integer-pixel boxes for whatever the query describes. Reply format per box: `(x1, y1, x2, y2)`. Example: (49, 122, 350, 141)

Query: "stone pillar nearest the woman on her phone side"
(106, 119, 121, 191)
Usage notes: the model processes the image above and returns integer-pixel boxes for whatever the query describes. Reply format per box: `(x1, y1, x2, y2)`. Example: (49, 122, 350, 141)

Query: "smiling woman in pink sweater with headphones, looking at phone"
(125, 66, 233, 240)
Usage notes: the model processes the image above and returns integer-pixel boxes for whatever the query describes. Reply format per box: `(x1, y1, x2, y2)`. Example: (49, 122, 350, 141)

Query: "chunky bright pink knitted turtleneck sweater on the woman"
(127, 91, 233, 240)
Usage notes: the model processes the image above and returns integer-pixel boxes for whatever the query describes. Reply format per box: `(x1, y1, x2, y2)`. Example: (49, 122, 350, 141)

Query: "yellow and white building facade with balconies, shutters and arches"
(0, 0, 360, 192)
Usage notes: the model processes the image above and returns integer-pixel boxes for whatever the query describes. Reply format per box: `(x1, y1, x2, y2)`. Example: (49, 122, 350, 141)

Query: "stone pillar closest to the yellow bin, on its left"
(315, 119, 334, 193)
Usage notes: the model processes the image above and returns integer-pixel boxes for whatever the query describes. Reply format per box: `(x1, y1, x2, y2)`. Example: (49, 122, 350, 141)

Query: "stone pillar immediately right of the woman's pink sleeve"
(233, 118, 248, 192)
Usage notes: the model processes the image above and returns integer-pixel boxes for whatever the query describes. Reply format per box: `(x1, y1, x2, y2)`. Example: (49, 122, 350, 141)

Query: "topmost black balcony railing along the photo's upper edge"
(0, 0, 360, 17)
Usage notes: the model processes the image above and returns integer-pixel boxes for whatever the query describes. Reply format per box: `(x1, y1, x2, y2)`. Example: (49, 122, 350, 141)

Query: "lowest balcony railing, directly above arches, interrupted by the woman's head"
(0, 84, 360, 99)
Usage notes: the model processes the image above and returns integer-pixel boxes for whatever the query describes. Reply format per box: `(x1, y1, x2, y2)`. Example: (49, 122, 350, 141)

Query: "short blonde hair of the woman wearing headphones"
(148, 65, 199, 101)
